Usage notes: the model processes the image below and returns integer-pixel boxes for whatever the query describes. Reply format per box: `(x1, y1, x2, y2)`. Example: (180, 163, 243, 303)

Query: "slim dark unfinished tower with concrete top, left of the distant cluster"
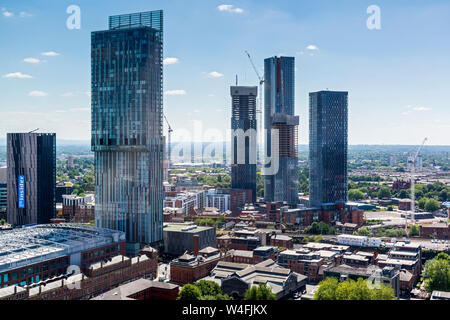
(230, 86, 258, 201)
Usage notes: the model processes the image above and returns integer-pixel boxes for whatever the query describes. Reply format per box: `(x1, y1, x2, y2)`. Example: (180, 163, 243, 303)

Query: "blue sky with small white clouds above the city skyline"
(0, 0, 450, 145)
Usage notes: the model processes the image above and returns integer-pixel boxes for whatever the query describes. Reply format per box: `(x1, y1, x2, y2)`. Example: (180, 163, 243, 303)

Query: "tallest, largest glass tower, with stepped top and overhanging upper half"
(91, 11, 164, 255)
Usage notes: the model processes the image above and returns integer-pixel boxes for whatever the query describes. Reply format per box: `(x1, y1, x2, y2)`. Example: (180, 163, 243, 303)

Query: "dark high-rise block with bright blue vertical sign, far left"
(7, 133, 56, 226)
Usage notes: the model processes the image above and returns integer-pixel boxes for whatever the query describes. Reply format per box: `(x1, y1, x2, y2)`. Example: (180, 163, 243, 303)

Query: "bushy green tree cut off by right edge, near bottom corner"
(423, 252, 450, 292)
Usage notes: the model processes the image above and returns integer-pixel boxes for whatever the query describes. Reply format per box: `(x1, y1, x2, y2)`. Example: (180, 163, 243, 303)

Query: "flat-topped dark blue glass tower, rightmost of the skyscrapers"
(309, 91, 348, 207)
